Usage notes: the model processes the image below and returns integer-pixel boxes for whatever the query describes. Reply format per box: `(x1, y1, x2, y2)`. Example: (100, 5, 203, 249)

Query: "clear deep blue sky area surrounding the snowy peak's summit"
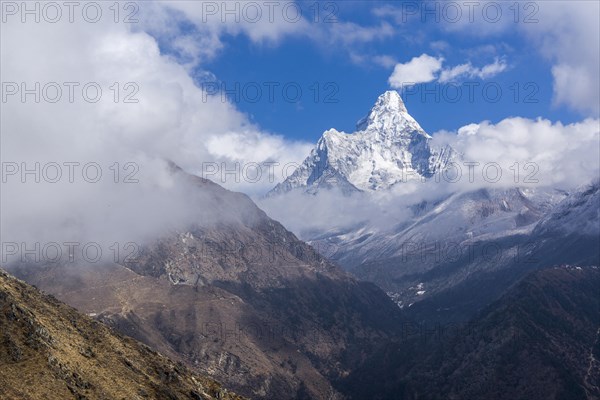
(151, 1, 596, 142)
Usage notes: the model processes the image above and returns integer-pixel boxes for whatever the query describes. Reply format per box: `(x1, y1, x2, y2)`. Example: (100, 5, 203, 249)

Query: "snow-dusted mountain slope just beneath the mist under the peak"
(311, 188, 567, 274)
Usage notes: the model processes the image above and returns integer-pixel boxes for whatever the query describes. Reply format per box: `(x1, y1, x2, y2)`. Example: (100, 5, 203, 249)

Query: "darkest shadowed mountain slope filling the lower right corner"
(345, 266, 600, 400)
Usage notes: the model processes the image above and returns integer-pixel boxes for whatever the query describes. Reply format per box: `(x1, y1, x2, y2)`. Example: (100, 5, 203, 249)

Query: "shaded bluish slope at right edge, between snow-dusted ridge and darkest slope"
(394, 181, 600, 321)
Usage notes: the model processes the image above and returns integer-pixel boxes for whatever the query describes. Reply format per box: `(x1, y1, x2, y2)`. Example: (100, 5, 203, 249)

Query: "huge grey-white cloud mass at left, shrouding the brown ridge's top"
(0, 3, 305, 253)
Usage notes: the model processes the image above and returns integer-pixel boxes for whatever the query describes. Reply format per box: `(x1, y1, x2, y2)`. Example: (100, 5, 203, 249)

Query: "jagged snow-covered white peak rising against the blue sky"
(269, 91, 452, 195)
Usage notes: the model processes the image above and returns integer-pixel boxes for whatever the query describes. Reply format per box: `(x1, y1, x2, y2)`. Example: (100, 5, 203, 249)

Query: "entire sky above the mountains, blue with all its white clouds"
(0, 0, 600, 195)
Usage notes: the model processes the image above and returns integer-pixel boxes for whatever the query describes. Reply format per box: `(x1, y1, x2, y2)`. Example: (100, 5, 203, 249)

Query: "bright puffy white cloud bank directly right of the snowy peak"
(433, 117, 600, 190)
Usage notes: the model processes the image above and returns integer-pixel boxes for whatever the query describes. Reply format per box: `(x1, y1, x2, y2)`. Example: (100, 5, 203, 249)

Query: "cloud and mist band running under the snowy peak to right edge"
(259, 117, 600, 237)
